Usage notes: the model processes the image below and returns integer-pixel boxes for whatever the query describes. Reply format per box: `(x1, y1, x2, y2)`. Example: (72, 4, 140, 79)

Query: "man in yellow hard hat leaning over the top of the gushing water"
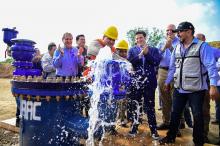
(87, 26, 118, 60)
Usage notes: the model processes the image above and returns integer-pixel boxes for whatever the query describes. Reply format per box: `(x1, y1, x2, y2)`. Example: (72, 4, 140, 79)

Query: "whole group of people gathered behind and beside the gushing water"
(24, 22, 220, 146)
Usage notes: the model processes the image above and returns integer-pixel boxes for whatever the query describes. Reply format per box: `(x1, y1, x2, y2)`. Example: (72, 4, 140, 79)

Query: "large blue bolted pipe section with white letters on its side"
(11, 81, 88, 146)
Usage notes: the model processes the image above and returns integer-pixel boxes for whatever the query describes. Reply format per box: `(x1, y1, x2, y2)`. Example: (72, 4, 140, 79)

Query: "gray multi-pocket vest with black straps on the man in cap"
(174, 41, 207, 91)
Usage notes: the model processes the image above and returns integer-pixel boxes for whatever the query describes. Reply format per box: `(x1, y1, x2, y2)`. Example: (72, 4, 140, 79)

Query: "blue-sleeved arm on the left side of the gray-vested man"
(165, 49, 176, 85)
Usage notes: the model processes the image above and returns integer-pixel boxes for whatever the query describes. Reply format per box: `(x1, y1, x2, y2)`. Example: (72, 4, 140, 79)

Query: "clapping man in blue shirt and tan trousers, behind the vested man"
(157, 24, 179, 130)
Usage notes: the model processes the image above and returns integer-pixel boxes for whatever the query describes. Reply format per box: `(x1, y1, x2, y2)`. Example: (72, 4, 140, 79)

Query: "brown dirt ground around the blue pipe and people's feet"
(0, 78, 219, 146)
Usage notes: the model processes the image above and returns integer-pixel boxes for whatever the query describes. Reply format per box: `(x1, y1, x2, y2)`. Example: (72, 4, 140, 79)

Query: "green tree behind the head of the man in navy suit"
(127, 27, 164, 47)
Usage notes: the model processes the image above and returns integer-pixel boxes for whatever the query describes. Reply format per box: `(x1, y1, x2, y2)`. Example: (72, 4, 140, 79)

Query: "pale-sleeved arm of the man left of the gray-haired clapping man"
(41, 54, 56, 72)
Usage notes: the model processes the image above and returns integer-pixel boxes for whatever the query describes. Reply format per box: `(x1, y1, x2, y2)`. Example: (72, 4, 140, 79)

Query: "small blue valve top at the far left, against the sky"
(2, 28, 18, 46)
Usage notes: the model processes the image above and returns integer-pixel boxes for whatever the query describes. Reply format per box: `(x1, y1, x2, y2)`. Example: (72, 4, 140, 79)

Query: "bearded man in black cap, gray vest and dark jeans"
(159, 22, 218, 146)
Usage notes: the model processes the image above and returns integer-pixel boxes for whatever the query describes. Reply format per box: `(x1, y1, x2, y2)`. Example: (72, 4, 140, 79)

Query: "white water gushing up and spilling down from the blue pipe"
(86, 47, 131, 146)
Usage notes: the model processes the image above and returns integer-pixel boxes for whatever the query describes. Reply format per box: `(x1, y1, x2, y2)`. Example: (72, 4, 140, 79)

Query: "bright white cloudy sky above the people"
(0, 0, 220, 60)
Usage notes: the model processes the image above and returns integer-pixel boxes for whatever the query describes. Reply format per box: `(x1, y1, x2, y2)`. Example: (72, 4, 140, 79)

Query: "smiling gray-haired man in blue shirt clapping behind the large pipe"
(53, 33, 84, 77)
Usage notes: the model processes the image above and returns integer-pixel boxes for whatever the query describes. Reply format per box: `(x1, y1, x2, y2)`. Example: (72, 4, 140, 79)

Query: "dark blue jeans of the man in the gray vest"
(167, 89, 205, 145)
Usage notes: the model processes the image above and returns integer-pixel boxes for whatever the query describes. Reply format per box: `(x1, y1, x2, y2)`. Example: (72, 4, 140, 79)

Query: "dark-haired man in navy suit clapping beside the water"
(128, 31, 161, 139)
